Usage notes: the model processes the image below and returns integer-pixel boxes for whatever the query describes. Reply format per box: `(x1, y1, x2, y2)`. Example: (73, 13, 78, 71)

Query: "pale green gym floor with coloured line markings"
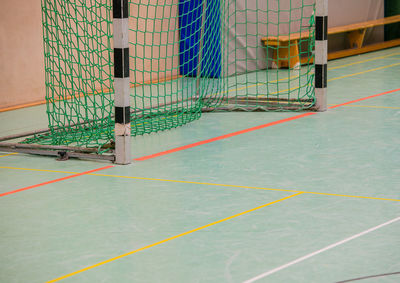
(0, 48, 400, 283)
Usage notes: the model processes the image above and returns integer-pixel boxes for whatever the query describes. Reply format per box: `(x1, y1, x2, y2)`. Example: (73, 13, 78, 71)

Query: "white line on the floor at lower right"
(243, 217, 400, 283)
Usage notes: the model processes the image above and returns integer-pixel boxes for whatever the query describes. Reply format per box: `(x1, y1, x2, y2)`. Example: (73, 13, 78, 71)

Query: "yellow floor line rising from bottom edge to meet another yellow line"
(47, 193, 302, 283)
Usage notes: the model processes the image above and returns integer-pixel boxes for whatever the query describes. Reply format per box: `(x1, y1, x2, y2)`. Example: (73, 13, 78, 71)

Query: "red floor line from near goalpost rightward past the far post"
(134, 88, 400, 161)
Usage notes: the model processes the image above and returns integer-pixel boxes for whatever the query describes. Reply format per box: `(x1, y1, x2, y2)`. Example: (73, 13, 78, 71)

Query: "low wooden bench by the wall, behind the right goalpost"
(261, 15, 400, 68)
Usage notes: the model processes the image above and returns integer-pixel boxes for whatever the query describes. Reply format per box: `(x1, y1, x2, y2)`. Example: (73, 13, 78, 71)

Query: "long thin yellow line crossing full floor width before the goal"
(0, 166, 400, 202)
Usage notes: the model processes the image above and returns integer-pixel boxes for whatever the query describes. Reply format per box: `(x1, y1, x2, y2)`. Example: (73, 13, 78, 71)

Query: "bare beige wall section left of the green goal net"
(0, 0, 45, 109)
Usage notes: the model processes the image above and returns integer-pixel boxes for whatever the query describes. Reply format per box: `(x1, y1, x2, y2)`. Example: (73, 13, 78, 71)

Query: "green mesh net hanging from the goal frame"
(24, 0, 315, 152)
